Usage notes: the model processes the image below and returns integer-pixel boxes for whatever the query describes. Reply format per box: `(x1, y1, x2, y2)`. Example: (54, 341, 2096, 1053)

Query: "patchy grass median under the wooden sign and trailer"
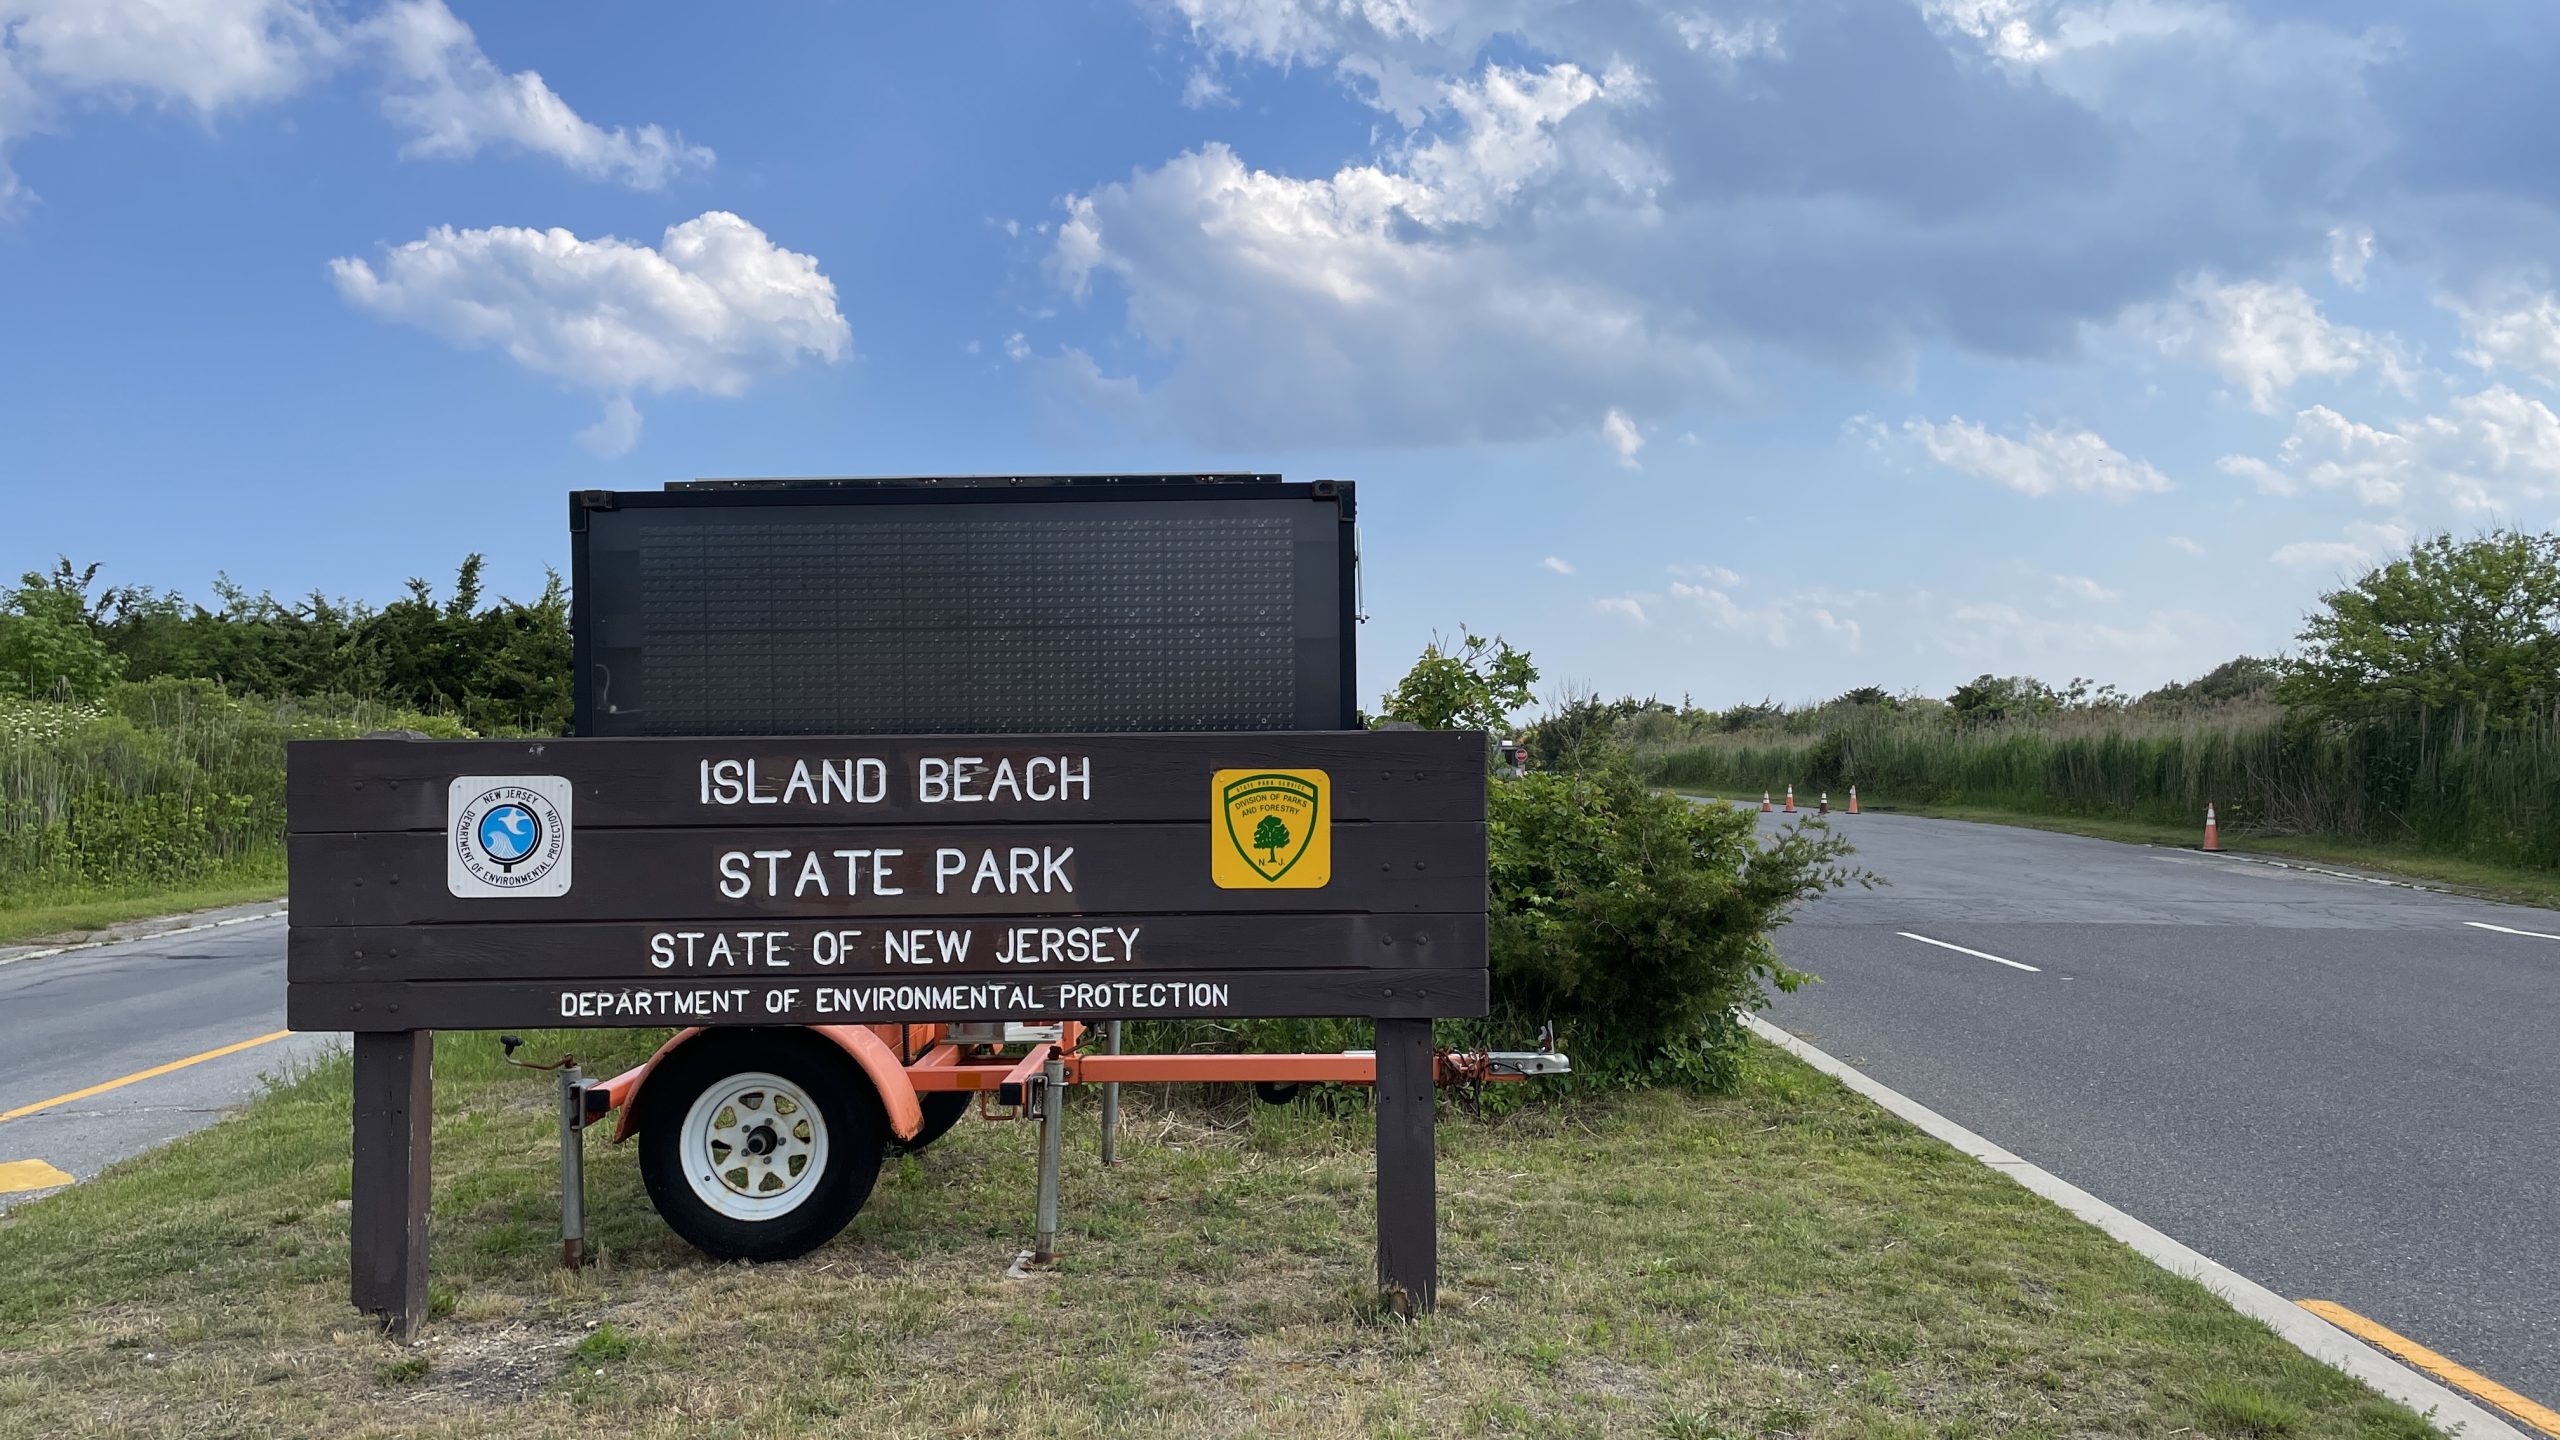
(0, 1033, 2429, 1440)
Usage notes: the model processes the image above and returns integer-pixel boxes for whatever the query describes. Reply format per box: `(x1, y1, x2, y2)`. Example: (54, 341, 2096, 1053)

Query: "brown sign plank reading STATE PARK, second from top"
(287, 819, 1485, 928)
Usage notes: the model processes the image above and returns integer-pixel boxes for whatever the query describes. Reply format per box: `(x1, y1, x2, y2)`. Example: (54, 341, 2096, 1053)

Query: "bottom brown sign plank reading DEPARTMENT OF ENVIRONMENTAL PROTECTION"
(284, 966, 1487, 1033)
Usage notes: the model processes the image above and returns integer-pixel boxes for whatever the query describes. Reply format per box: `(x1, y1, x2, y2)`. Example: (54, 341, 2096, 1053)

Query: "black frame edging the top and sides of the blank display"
(568, 471, 1359, 735)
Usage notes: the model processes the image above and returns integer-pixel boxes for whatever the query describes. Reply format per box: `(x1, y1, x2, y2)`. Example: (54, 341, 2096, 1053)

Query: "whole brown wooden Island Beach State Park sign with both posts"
(287, 730, 1487, 1332)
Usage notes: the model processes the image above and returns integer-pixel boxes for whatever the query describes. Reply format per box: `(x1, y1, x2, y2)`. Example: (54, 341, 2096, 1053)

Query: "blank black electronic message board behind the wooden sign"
(573, 482, 1352, 735)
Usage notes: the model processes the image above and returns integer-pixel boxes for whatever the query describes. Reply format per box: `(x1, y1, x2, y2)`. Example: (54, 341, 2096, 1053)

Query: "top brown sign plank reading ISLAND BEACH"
(284, 730, 1485, 835)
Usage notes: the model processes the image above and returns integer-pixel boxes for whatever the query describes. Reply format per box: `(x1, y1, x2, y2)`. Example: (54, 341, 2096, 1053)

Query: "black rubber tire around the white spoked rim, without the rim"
(640, 1030, 888, 1261)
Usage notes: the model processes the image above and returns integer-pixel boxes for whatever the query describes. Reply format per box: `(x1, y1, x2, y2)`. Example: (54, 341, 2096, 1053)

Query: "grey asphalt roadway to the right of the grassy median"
(1761, 799, 2560, 1404)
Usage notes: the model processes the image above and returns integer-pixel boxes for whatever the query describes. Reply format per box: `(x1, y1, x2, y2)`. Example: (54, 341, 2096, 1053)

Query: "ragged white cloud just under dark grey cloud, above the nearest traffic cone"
(2138, 277, 2409, 415)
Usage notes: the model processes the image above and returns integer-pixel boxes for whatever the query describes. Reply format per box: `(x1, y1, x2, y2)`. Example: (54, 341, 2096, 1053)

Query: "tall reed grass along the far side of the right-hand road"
(1646, 707, 2560, 869)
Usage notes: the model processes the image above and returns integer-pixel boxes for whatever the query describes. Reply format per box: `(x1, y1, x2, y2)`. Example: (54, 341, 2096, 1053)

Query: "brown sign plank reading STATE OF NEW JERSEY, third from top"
(284, 912, 1485, 984)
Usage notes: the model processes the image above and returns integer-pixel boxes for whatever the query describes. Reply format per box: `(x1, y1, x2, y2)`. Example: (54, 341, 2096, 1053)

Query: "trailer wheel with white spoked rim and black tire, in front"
(640, 1030, 888, 1261)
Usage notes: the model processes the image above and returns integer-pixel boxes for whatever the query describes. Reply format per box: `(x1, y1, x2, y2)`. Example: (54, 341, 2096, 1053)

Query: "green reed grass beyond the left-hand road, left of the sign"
(0, 679, 466, 907)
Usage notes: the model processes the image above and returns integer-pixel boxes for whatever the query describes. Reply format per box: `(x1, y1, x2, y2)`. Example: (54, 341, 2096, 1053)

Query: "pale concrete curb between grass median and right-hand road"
(1743, 1015, 2534, 1440)
